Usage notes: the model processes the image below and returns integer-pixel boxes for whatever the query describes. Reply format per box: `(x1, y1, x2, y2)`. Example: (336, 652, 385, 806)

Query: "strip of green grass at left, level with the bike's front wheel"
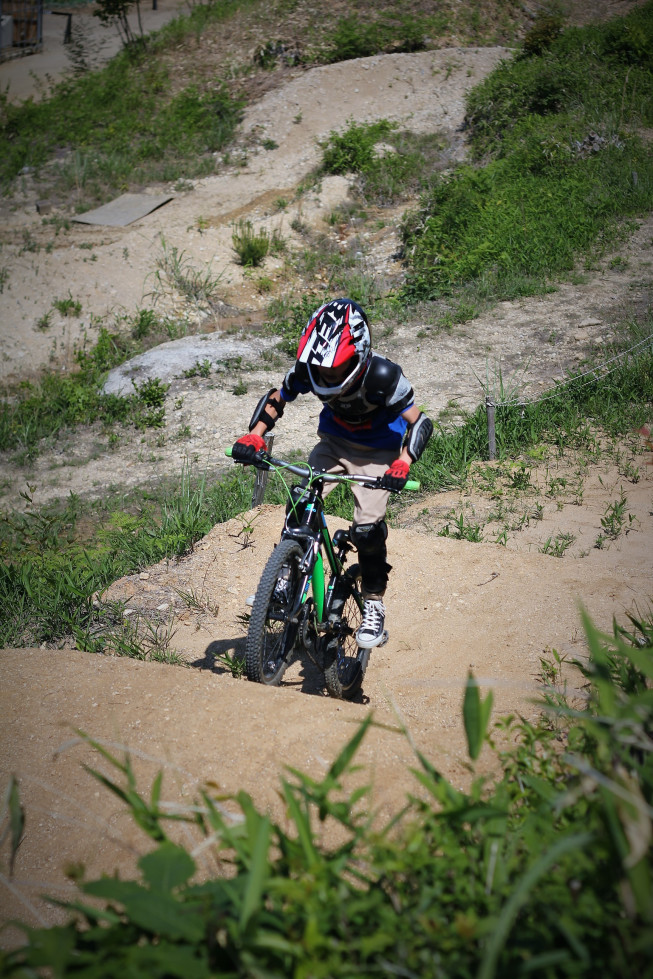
(0, 472, 251, 652)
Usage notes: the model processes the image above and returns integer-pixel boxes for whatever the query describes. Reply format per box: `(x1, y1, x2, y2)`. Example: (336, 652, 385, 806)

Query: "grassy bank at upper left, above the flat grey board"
(0, 49, 241, 201)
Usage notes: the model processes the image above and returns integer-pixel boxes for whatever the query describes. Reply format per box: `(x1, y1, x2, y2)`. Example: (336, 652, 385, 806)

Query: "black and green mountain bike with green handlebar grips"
(226, 449, 419, 700)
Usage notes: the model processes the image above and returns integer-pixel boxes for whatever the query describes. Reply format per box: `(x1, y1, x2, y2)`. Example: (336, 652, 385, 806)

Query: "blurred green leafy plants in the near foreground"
(0, 614, 653, 979)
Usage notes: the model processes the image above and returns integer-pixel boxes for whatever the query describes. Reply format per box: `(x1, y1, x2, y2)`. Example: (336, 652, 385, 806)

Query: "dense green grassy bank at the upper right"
(403, 3, 653, 300)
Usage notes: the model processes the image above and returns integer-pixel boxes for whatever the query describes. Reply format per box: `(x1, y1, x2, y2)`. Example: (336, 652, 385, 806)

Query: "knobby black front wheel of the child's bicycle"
(245, 540, 302, 686)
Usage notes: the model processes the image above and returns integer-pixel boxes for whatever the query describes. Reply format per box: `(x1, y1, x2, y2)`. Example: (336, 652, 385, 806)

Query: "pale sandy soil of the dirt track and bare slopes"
(0, 3, 653, 941)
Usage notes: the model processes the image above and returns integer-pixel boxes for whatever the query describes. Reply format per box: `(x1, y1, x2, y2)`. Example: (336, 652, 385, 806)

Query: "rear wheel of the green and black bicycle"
(323, 565, 370, 700)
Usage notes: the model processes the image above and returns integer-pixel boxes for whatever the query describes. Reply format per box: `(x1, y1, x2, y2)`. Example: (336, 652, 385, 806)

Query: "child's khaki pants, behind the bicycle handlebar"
(308, 435, 392, 525)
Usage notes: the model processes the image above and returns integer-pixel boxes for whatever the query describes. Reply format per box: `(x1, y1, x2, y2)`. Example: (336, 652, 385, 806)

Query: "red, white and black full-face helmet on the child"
(297, 299, 372, 399)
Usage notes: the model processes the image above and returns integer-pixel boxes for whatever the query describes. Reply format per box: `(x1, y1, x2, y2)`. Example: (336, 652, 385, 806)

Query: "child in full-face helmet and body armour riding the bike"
(232, 299, 433, 649)
